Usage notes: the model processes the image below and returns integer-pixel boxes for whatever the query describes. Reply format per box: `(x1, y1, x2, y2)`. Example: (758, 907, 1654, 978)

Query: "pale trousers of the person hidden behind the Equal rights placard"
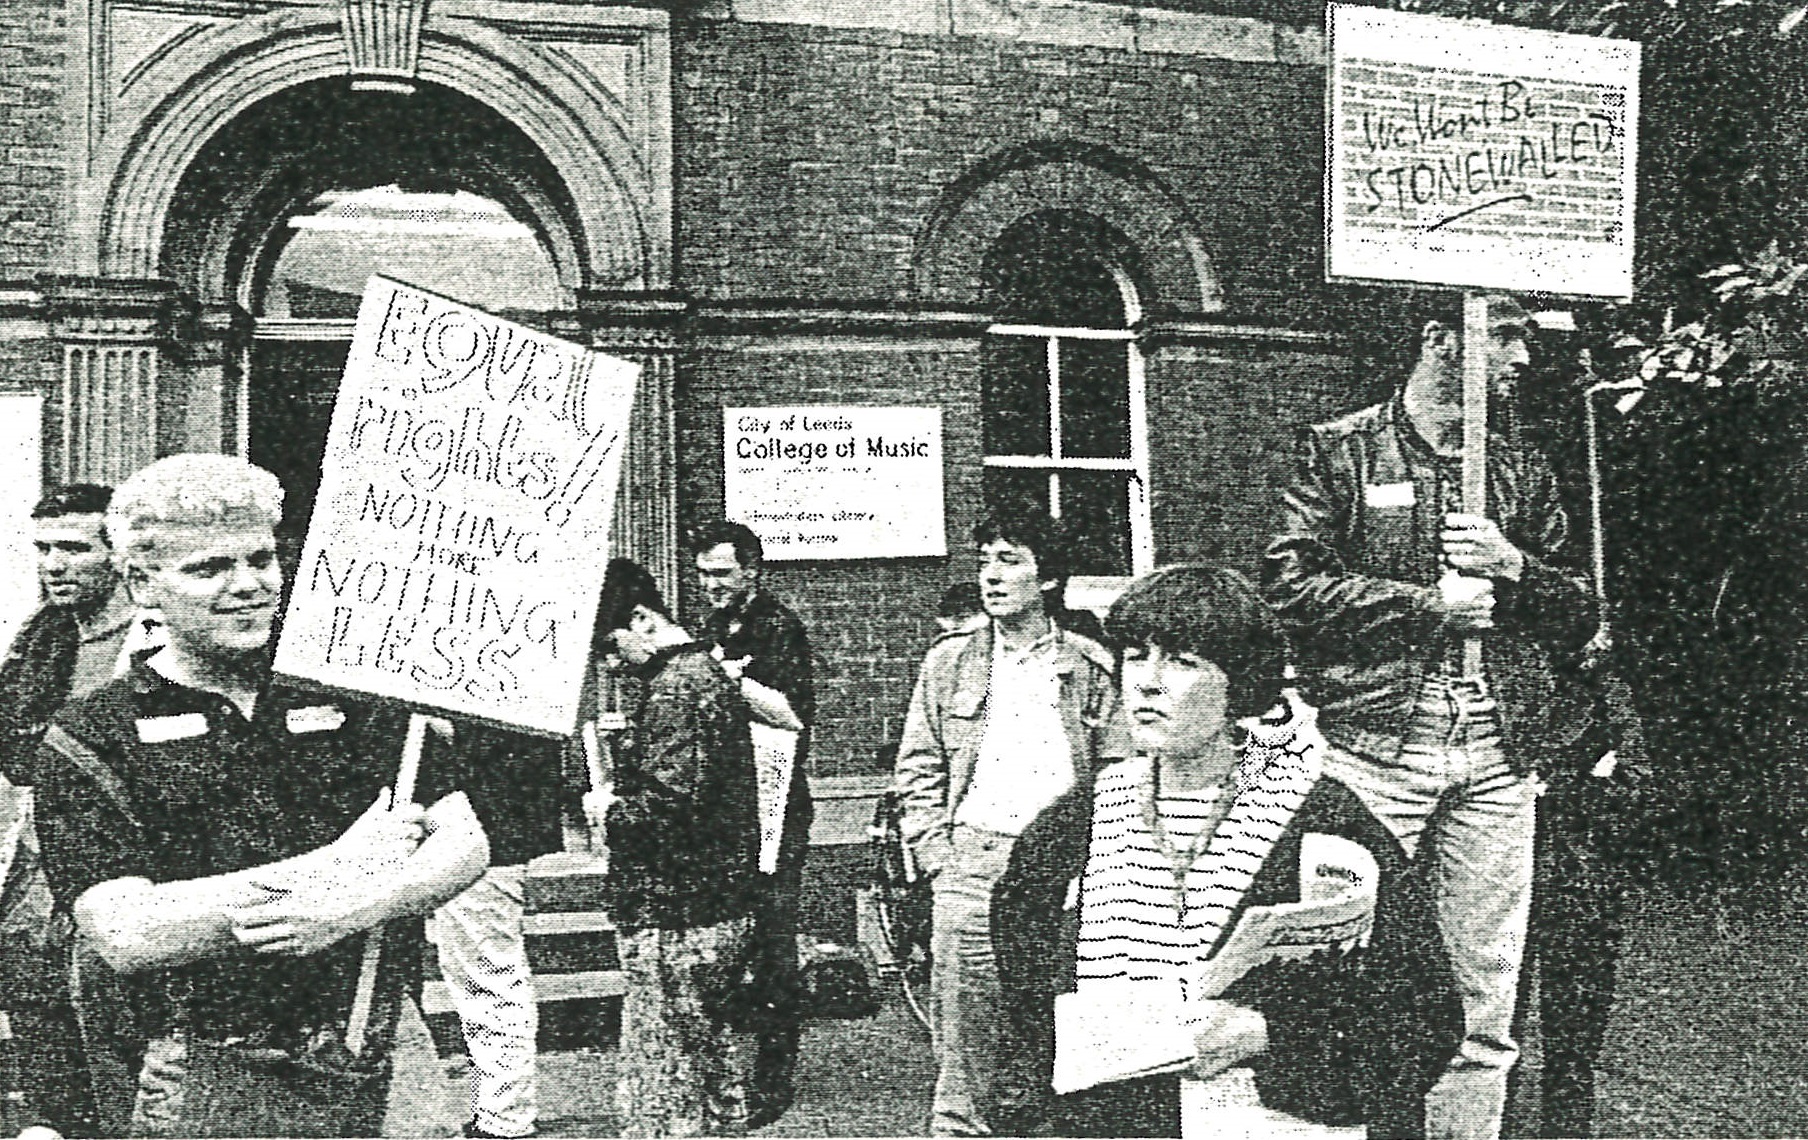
(427, 867, 541, 1136)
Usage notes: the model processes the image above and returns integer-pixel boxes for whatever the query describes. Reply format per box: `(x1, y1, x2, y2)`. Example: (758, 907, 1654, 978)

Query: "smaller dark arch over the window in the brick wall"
(911, 143, 1224, 314)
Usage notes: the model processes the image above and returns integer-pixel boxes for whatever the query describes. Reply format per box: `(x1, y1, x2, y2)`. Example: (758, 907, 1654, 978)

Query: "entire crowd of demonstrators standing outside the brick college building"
(0, 287, 1640, 1140)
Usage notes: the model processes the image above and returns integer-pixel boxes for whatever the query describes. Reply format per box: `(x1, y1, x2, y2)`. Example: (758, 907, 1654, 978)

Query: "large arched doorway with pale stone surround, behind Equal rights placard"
(65, 0, 676, 582)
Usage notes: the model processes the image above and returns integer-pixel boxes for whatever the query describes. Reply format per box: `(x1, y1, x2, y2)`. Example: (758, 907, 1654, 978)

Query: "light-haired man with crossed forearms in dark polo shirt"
(38, 455, 488, 1136)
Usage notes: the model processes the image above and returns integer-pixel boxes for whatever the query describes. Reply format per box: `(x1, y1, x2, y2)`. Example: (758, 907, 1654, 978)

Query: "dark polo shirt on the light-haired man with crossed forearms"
(38, 663, 461, 1048)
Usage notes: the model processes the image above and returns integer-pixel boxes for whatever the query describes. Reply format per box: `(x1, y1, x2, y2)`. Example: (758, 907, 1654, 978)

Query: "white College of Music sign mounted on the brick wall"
(721, 406, 947, 562)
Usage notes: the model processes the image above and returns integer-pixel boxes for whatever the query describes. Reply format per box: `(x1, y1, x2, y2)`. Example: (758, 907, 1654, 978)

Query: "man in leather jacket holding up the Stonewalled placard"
(1264, 298, 1595, 1138)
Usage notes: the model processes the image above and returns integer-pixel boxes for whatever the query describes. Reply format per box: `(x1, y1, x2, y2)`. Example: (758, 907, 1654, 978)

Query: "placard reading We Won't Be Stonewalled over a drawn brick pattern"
(1325, 4, 1640, 298)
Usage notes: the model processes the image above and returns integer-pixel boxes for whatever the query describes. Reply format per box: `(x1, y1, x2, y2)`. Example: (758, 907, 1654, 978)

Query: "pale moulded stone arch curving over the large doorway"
(93, 7, 671, 291)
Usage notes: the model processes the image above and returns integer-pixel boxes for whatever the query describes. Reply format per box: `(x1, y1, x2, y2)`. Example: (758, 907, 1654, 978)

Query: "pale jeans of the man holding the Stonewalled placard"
(1325, 677, 1537, 1140)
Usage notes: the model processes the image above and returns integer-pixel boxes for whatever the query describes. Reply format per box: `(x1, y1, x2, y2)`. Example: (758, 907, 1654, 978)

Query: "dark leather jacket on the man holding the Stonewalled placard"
(1262, 396, 1596, 770)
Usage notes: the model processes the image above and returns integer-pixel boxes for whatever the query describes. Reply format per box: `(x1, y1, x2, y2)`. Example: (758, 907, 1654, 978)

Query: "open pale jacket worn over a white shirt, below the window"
(897, 621, 1130, 876)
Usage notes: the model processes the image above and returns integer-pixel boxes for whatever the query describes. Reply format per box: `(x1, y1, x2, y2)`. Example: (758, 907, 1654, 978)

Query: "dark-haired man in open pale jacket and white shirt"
(897, 511, 1128, 1136)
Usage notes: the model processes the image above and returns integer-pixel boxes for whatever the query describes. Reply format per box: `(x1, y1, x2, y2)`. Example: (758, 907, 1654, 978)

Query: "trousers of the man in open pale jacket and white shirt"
(929, 826, 1036, 1136)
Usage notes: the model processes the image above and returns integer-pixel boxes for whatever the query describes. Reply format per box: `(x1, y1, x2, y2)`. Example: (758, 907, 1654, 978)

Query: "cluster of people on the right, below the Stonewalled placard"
(897, 298, 1640, 1138)
